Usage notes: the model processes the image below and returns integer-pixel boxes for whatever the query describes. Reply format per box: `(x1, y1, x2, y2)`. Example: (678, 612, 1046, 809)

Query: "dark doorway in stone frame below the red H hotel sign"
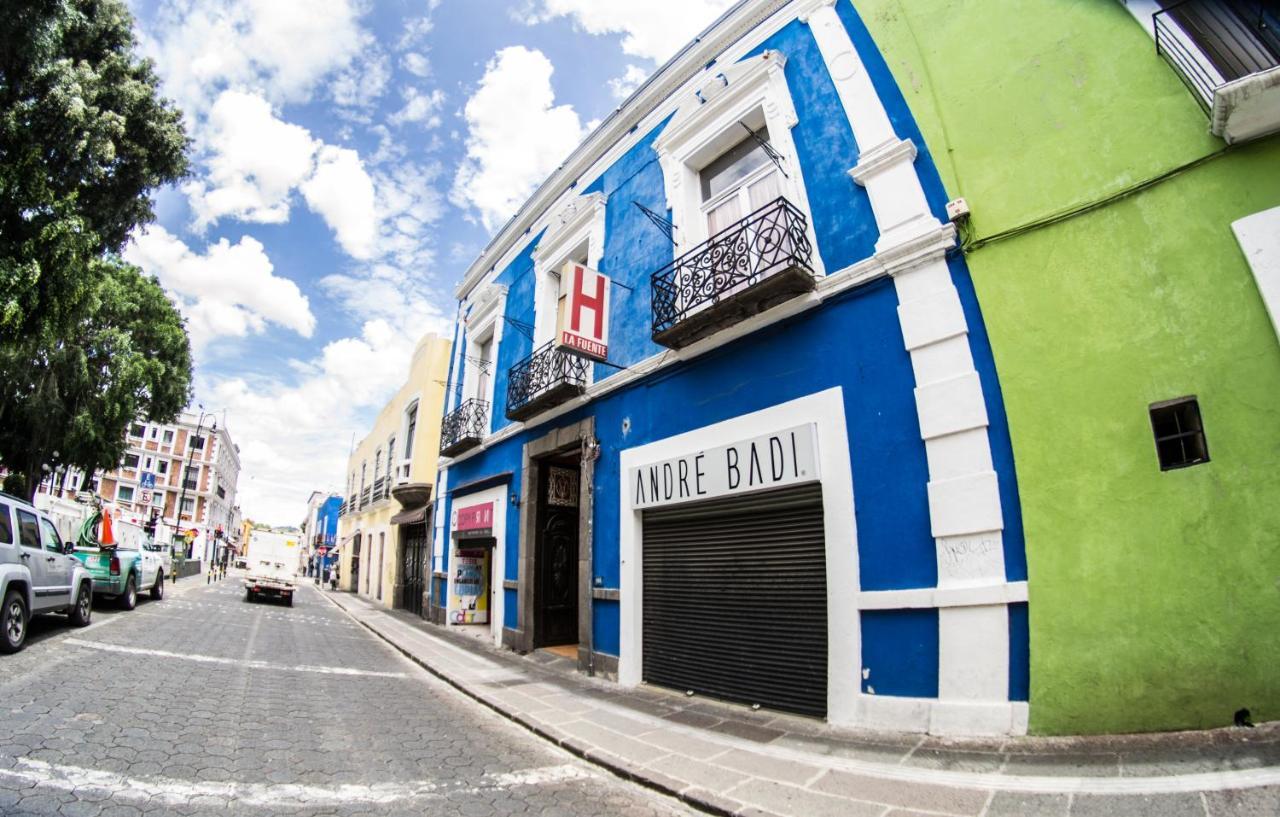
(534, 455, 581, 647)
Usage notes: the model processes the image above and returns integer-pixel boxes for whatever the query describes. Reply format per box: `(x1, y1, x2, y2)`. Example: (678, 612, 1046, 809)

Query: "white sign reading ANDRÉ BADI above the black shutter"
(627, 424, 819, 510)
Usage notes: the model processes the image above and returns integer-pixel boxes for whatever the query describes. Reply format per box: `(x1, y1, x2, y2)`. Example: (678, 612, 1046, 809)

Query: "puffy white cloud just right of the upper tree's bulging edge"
(183, 91, 317, 229)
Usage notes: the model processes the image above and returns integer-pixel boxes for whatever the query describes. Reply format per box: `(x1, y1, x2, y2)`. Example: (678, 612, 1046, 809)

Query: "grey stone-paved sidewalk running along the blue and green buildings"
(324, 590, 1280, 817)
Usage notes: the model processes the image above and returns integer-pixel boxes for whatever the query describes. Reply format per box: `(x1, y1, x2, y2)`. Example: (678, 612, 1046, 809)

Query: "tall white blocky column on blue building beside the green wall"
(801, 0, 1018, 734)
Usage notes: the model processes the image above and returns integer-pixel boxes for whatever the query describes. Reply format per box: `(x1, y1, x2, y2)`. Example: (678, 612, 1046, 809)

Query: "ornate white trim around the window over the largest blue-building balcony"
(654, 51, 826, 275)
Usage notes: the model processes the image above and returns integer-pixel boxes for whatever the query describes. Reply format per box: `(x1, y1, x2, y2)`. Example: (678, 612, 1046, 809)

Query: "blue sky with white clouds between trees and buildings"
(124, 0, 733, 524)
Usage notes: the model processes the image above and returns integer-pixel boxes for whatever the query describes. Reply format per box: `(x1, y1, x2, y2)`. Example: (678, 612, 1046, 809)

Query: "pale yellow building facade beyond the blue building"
(338, 334, 452, 607)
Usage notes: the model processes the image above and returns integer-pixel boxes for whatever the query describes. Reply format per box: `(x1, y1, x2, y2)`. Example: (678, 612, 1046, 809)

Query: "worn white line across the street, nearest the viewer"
(0, 758, 598, 808)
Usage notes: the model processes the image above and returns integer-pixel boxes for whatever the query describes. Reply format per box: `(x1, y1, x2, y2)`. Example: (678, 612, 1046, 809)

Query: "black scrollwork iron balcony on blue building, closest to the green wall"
(652, 197, 815, 348)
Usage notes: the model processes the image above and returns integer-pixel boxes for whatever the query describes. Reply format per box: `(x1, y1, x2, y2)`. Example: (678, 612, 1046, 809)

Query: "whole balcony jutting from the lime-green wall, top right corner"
(1151, 0, 1280, 142)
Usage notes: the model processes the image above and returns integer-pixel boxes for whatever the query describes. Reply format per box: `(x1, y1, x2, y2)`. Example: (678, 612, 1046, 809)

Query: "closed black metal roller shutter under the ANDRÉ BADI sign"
(643, 483, 827, 717)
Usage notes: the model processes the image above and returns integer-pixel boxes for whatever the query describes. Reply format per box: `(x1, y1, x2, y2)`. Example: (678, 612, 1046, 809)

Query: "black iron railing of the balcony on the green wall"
(1151, 0, 1280, 113)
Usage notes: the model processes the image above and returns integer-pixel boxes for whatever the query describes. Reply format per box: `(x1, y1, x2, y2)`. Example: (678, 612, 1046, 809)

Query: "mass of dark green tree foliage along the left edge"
(0, 0, 191, 496)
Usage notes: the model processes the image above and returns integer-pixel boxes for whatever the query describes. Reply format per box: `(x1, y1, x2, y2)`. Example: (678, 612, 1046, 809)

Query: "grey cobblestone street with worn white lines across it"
(0, 578, 690, 817)
